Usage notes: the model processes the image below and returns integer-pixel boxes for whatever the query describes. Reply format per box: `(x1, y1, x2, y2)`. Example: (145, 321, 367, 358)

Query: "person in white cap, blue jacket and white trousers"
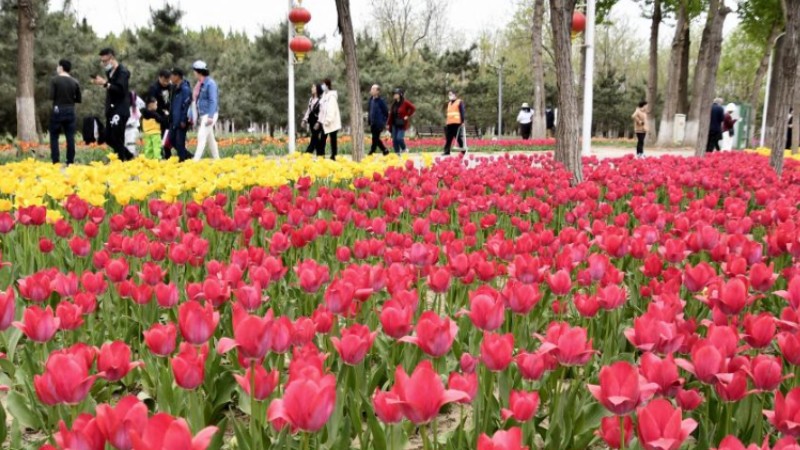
(192, 60, 219, 161)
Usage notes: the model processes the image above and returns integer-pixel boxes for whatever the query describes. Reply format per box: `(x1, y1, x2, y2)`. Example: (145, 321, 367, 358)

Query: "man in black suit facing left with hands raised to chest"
(92, 48, 133, 161)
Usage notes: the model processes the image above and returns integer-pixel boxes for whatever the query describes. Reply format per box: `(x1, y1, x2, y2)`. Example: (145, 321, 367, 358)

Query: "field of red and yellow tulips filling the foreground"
(0, 152, 800, 450)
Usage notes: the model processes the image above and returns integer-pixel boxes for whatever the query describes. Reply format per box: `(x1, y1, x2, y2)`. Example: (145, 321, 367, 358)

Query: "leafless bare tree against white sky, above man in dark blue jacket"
(370, 0, 448, 62)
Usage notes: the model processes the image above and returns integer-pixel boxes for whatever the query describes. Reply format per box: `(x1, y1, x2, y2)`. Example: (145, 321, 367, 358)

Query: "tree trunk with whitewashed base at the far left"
(17, 0, 36, 142)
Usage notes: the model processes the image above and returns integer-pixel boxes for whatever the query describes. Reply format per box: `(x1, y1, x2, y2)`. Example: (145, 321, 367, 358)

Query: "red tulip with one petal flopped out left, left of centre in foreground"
(217, 304, 274, 363)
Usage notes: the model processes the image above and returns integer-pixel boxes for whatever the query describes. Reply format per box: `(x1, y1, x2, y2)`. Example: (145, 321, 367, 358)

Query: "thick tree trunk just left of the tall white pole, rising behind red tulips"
(550, 0, 583, 185)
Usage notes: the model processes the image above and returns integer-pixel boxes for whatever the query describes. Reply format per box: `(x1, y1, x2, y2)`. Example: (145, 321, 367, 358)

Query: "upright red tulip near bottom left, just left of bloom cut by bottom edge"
(97, 395, 147, 450)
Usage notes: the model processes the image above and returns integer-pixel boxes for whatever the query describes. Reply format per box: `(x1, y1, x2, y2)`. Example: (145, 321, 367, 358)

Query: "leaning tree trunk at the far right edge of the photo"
(767, 0, 800, 176)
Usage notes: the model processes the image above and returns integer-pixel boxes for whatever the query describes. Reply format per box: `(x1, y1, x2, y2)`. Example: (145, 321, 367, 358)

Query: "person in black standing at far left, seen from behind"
(50, 59, 81, 166)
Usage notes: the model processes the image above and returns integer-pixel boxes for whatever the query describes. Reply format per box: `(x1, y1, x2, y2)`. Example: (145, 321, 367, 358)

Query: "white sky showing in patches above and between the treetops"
(50, 0, 736, 46)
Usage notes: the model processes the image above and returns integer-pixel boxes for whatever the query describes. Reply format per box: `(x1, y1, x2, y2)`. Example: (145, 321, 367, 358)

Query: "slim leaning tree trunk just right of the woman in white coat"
(336, 0, 364, 161)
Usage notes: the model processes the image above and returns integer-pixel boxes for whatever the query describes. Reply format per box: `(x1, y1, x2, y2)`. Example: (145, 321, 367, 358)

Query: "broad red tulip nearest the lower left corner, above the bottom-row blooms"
(33, 352, 101, 406)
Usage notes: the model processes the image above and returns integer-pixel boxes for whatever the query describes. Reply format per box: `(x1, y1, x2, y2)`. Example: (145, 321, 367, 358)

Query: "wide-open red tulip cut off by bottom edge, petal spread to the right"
(131, 413, 217, 450)
